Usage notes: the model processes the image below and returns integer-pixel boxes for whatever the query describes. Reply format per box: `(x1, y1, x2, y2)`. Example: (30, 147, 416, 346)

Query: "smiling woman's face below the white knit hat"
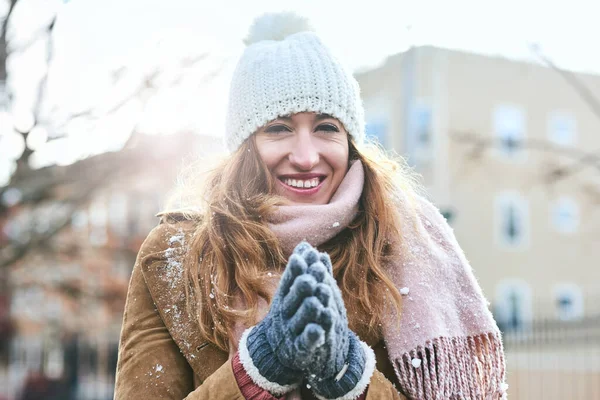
(255, 112, 348, 204)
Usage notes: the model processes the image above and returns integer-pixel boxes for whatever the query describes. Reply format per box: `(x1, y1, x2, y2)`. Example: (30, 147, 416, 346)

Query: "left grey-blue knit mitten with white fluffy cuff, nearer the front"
(239, 243, 331, 395)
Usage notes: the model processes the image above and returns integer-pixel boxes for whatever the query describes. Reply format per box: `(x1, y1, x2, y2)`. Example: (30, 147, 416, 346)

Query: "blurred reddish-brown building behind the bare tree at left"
(0, 134, 222, 400)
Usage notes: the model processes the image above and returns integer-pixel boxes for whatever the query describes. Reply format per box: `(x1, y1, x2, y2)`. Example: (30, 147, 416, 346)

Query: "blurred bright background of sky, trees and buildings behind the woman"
(0, 0, 600, 400)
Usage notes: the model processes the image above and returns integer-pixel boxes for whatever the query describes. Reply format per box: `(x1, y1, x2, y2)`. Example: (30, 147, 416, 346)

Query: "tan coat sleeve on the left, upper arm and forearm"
(114, 223, 243, 400)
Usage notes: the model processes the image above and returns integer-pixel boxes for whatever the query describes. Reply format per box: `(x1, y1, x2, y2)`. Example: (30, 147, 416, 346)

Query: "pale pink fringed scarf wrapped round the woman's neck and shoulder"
(270, 161, 507, 400)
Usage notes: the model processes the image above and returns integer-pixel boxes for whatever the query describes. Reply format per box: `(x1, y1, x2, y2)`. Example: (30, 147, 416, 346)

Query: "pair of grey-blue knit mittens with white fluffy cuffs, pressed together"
(240, 242, 374, 399)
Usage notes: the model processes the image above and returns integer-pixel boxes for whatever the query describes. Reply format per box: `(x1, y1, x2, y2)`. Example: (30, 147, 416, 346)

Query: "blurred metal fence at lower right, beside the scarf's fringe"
(504, 315, 600, 400)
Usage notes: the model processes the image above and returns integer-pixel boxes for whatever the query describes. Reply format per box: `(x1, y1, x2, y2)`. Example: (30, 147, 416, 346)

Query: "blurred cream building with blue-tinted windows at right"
(357, 47, 600, 399)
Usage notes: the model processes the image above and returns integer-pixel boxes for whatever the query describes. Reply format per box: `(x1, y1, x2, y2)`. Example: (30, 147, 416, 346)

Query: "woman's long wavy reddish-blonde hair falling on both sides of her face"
(171, 136, 417, 351)
